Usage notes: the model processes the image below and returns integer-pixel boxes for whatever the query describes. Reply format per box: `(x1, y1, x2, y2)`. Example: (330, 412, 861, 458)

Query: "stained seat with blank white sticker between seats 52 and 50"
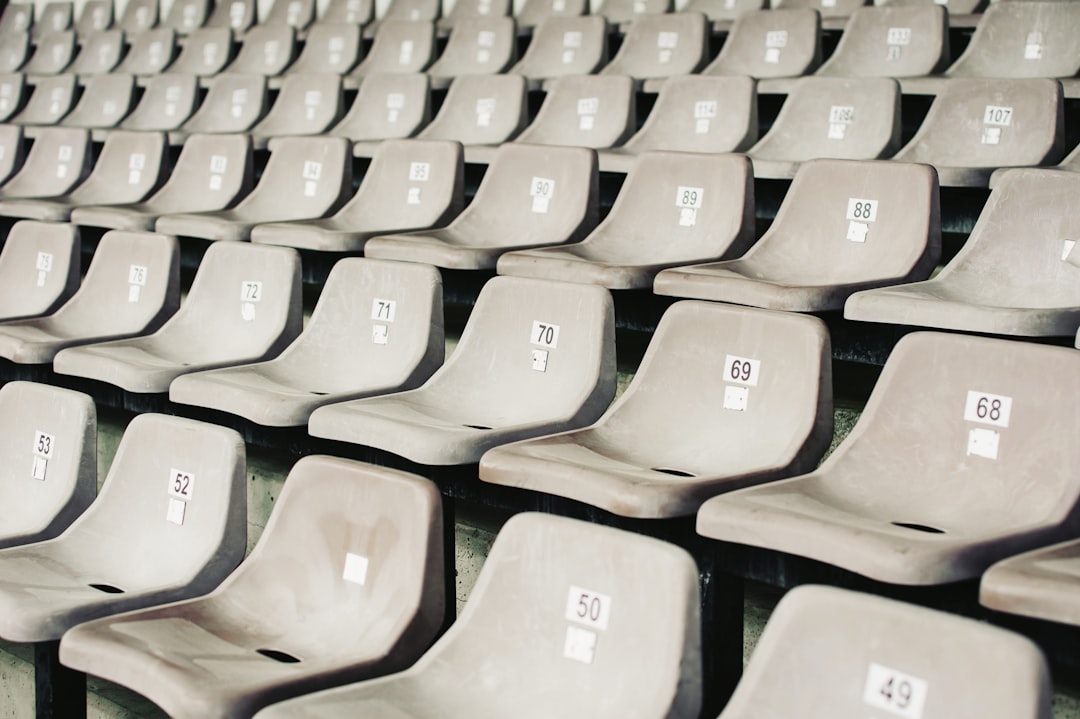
(60, 457, 454, 719)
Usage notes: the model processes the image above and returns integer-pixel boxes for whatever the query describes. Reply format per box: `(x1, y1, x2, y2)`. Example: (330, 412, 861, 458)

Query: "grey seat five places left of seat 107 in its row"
(328, 73, 431, 141)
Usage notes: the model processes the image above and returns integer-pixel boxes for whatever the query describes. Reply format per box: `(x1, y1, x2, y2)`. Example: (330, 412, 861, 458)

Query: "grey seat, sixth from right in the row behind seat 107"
(428, 17, 517, 90)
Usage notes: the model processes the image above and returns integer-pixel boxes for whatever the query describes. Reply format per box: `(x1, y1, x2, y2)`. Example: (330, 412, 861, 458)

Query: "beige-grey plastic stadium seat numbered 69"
(480, 301, 833, 519)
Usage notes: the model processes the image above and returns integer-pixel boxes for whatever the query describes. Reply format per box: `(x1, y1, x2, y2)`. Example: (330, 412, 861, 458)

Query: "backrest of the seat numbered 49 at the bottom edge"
(720, 586, 1052, 719)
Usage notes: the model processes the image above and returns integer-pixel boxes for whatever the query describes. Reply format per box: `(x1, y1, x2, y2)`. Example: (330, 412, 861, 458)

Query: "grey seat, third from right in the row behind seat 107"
(704, 8, 821, 78)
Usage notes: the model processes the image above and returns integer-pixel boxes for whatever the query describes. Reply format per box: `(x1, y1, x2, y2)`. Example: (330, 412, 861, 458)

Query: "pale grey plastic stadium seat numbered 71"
(168, 257, 444, 426)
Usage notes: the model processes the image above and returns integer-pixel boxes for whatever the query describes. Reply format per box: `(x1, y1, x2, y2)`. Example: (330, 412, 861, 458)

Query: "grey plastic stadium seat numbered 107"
(893, 77, 1064, 167)
